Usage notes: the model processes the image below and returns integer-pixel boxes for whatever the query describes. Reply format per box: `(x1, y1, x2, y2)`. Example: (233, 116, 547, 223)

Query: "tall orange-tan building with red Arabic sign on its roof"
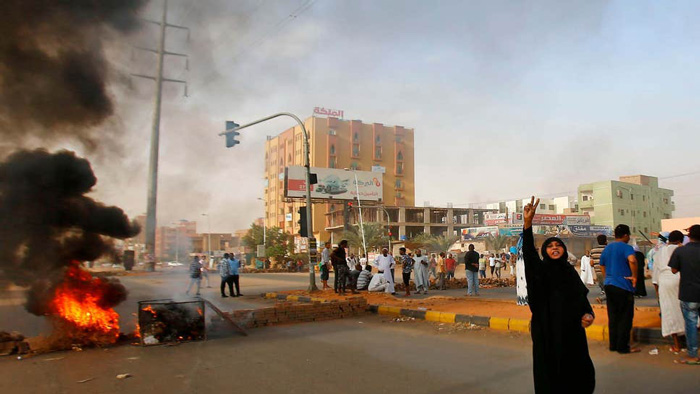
(264, 116, 415, 239)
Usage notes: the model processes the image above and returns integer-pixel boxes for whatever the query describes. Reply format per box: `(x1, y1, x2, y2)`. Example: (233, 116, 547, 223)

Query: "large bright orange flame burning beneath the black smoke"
(52, 264, 119, 341)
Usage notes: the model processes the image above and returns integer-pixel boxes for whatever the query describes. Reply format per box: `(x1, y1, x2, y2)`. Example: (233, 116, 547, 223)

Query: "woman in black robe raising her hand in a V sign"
(522, 197, 595, 394)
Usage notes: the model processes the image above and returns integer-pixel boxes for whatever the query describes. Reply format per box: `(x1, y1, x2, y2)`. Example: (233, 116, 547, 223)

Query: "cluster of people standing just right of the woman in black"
(579, 224, 700, 365)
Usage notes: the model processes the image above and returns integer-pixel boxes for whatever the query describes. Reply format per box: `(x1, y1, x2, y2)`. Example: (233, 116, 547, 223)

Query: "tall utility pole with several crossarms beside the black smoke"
(131, 0, 189, 271)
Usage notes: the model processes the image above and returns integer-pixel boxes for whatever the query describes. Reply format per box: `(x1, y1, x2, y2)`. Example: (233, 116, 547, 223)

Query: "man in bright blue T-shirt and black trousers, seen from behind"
(600, 224, 640, 354)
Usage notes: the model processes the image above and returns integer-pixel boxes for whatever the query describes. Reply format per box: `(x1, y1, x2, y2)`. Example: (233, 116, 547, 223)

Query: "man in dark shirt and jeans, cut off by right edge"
(668, 224, 700, 365)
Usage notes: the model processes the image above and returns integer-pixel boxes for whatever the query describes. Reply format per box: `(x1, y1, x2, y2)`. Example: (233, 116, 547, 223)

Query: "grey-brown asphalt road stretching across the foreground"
(0, 315, 698, 394)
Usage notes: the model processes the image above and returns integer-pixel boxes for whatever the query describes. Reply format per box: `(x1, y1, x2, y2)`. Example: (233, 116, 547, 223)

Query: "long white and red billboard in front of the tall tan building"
(284, 166, 384, 201)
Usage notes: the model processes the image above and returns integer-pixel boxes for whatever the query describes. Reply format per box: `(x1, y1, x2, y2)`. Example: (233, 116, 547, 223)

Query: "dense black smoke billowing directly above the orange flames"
(0, 149, 139, 315)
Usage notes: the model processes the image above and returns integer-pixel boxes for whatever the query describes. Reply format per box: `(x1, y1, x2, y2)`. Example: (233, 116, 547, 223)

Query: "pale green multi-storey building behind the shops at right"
(578, 175, 676, 237)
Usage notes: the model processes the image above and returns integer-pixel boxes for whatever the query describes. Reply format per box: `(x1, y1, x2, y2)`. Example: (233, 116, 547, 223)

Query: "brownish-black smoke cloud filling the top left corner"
(0, 0, 146, 145)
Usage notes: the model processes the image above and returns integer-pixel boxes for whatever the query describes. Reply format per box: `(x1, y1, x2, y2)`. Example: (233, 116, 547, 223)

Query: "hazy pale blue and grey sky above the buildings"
(39, 0, 700, 232)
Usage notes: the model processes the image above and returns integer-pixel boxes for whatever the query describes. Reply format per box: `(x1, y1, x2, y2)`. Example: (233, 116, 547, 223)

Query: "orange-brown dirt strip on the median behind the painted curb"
(280, 290, 661, 328)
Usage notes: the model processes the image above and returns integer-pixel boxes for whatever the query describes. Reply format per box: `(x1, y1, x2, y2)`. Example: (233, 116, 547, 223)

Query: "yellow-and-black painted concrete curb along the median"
(262, 293, 667, 344)
